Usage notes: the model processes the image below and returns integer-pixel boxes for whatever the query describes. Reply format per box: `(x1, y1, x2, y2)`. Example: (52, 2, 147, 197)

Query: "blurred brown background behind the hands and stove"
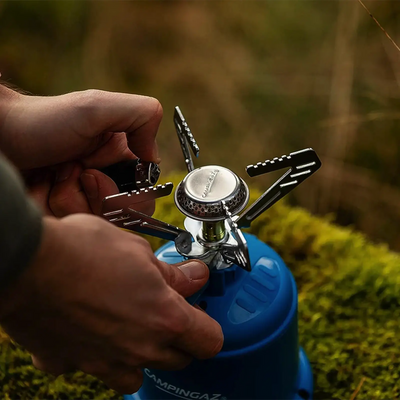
(0, 0, 400, 250)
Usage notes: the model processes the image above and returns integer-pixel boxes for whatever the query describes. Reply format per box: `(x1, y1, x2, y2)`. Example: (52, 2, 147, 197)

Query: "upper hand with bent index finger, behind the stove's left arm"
(0, 86, 162, 217)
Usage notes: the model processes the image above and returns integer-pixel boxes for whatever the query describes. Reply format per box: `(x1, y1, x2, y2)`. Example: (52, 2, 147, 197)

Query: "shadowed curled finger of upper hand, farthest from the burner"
(49, 163, 92, 218)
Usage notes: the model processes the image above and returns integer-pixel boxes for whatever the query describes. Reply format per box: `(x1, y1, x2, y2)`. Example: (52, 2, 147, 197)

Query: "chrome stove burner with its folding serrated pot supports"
(103, 107, 321, 271)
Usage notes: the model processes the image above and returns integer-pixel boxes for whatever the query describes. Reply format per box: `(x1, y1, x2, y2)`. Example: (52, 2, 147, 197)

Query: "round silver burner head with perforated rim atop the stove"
(175, 165, 249, 221)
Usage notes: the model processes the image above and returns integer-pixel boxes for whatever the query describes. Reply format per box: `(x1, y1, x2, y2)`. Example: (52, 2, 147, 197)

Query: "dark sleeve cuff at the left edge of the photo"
(0, 153, 42, 291)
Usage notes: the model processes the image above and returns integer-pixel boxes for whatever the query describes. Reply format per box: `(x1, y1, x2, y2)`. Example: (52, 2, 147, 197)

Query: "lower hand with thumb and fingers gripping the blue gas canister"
(0, 214, 223, 393)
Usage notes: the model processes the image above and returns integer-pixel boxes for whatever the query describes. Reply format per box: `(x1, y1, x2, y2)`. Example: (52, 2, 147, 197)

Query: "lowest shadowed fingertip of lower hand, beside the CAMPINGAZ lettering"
(95, 368, 143, 394)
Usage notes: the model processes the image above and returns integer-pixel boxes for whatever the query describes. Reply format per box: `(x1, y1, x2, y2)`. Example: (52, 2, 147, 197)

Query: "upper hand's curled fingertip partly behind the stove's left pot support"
(81, 169, 155, 215)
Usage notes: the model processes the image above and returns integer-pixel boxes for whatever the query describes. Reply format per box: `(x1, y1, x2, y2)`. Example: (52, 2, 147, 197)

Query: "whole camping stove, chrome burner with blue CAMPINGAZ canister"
(103, 107, 321, 400)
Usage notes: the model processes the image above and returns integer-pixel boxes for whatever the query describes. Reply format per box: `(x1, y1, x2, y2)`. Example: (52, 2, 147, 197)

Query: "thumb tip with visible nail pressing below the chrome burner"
(158, 260, 210, 297)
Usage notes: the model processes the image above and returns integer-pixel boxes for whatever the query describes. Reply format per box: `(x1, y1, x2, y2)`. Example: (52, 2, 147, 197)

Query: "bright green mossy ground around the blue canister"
(0, 176, 400, 400)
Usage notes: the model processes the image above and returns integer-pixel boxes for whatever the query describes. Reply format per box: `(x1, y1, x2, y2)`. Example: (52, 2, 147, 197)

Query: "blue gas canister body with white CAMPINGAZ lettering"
(125, 234, 313, 400)
